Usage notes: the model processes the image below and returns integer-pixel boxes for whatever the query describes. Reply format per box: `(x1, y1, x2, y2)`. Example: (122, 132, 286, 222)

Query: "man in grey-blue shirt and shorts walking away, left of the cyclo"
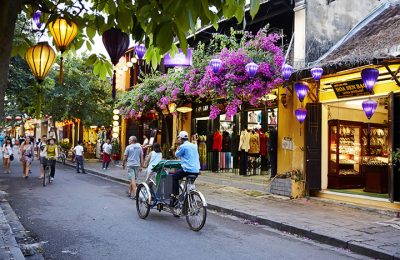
(123, 136, 143, 198)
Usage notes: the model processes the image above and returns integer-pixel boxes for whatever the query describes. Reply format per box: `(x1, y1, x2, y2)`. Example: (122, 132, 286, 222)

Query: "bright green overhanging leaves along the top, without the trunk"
(13, 0, 260, 74)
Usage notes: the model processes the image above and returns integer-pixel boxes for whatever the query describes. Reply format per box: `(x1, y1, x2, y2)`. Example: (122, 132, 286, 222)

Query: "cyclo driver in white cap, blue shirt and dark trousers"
(171, 131, 200, 206)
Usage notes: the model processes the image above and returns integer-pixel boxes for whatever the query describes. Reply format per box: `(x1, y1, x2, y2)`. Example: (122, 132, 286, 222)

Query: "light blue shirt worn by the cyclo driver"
(175, 141, 200, 173)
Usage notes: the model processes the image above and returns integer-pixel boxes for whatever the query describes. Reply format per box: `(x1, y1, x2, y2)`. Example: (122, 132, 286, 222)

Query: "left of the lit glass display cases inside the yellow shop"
(328, 120, 363, 189)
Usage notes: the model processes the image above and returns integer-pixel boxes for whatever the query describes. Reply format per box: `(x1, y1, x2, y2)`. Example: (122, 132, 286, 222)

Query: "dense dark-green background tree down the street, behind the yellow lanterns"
(43, 55, 112, 125)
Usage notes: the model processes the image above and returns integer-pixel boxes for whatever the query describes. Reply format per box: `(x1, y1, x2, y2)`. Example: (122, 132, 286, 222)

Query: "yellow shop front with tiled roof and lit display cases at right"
(278, 4, 400, 205)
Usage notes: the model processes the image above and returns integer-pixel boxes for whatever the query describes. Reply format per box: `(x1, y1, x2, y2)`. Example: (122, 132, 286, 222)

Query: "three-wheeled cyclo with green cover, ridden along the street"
(136, 160, 207, 231)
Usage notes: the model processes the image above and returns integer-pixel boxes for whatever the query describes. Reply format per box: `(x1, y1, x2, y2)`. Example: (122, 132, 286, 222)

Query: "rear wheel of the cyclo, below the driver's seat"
(185, 191, 207, 231)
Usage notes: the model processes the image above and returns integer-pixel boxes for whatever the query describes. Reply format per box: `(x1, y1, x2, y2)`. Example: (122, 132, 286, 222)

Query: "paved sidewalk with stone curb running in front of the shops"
(68, 162, 400, 259)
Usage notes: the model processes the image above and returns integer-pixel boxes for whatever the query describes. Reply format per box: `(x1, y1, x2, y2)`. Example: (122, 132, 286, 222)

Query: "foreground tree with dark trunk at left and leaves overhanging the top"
(0, 0, 260, 115)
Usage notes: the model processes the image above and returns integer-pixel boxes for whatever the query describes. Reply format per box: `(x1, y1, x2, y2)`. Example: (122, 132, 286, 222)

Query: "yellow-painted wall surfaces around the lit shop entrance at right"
(278, 66, 400, 181)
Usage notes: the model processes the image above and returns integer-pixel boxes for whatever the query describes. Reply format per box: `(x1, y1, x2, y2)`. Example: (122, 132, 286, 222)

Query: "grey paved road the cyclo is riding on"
(0, 162, 365, 259)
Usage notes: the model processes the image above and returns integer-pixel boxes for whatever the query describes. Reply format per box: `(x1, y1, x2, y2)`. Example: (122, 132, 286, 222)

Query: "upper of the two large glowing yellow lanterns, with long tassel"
(49, 17, 78, 83)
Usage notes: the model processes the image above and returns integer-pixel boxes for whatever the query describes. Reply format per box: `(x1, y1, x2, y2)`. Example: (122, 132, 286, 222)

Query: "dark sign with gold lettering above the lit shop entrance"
(332, 79, 373, 98)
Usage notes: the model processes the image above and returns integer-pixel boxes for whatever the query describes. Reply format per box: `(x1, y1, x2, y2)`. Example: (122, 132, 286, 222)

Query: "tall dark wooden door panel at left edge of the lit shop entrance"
(304, 103, 322, 191)
